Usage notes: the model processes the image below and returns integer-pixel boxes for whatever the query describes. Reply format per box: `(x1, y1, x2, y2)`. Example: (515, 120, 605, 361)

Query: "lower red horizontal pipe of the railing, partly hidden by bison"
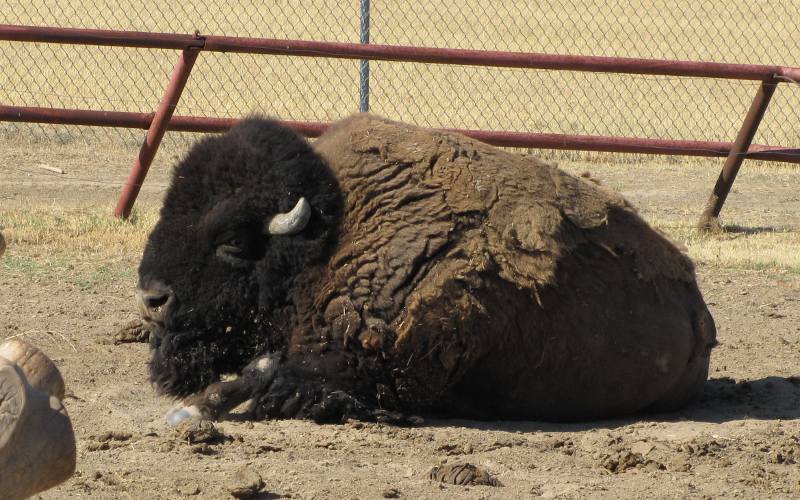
(0, 106, 800, 163)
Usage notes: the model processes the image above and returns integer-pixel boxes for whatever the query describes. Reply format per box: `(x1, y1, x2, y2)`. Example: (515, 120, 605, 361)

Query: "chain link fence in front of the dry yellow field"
(0, 0, 800, 160)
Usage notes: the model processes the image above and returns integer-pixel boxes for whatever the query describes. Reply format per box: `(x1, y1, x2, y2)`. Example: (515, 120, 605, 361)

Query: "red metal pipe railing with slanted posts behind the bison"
(0, 25, 800, 227)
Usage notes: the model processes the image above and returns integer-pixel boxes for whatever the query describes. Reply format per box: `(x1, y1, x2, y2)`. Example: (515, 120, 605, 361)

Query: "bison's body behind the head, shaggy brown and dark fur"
(315, 115, 715, 420)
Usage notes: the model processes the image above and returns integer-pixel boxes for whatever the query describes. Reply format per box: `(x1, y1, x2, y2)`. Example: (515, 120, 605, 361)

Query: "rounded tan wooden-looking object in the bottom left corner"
(0, 340, 76, 500)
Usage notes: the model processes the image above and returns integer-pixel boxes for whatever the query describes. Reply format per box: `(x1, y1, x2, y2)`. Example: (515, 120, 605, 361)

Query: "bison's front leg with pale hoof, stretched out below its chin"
(166, 353, 280, 425)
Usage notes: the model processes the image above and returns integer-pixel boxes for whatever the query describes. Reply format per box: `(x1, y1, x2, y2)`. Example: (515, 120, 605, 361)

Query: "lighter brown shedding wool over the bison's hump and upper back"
(315, 114, 694, 310)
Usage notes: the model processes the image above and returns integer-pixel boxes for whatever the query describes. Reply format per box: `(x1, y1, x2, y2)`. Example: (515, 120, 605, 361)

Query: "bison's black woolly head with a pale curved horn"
(136, 118, 342, 396)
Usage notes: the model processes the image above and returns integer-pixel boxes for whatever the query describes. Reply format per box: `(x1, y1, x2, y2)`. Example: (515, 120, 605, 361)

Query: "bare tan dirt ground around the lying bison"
(0, 145, 800, 499)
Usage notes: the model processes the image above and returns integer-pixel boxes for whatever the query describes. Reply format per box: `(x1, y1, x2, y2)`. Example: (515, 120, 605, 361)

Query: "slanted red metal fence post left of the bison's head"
(114, 47, 201, 219)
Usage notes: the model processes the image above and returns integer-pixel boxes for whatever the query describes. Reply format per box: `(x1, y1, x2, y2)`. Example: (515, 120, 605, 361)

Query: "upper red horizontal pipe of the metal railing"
(0, 25, 800, 81)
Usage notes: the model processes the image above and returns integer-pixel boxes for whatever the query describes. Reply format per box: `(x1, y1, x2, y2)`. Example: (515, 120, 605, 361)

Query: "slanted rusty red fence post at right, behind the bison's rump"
(697, 80, 778, 231)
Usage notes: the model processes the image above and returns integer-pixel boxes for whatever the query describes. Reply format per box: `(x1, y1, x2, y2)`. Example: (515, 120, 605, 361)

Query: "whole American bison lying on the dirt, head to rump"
(137, 115, 716, 422)
